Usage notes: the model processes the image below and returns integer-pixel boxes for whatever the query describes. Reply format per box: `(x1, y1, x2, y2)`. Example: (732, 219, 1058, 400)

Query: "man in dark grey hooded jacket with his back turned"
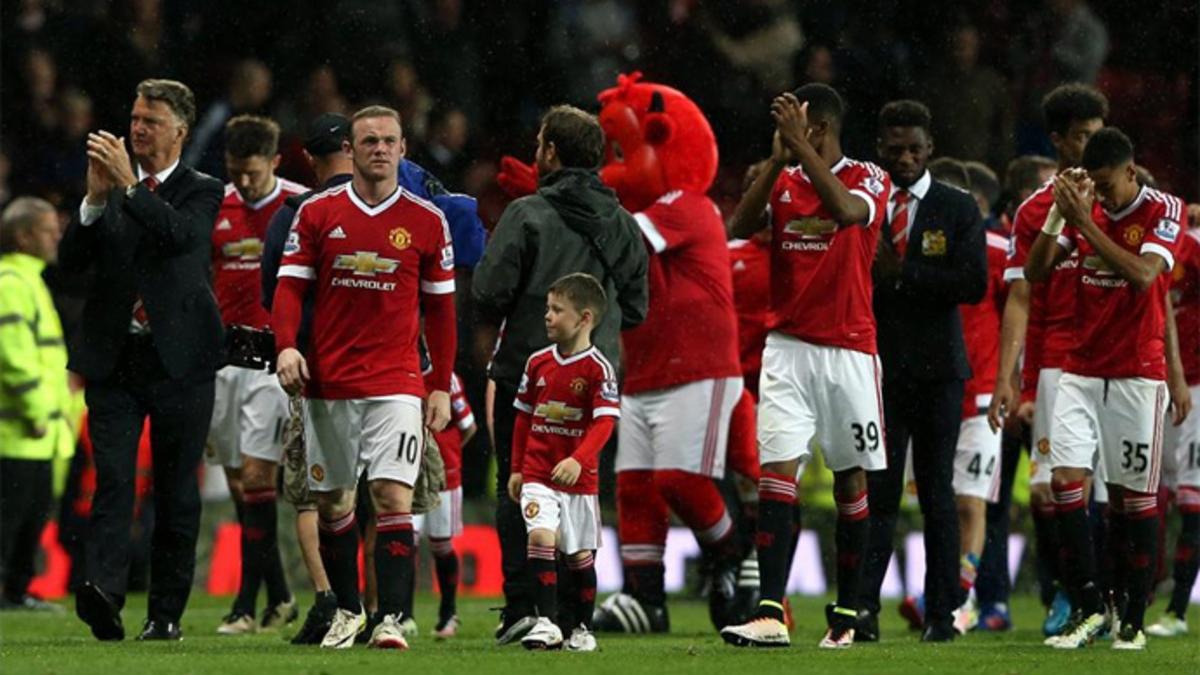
(472, 106, 648, 644)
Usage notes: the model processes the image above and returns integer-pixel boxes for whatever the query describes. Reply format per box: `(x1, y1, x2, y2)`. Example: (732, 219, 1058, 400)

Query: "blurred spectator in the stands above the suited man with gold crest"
(917, 24, 1014, 172)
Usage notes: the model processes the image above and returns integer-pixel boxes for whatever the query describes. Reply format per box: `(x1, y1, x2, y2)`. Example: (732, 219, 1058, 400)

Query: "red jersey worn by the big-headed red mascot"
(622, 191, 742, 394)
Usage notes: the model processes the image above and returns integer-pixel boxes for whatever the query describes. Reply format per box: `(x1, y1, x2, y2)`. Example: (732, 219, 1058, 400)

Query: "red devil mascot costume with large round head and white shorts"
(500, 73, 757, 633)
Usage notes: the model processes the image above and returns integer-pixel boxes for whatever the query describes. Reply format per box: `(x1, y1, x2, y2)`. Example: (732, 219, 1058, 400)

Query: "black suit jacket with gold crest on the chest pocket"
(874, 180, 988, 381)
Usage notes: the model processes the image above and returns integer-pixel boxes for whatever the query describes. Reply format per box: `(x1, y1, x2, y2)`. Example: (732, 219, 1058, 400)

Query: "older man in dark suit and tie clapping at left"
(59, 79, 223, 640)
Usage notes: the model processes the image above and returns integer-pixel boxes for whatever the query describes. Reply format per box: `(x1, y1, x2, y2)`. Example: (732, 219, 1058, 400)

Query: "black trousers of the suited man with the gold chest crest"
(860, 378, 962, 623)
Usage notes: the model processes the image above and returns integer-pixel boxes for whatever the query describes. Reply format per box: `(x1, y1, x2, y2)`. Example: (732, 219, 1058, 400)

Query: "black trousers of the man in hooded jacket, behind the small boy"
(493, 382, 533, 616)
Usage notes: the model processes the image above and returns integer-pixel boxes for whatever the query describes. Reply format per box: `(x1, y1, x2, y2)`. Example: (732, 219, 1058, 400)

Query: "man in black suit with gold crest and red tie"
(856, 101, 988, 641)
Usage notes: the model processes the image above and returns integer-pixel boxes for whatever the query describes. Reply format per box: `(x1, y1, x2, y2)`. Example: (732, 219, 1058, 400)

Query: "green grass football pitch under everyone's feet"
(0, 595, 1200, 675)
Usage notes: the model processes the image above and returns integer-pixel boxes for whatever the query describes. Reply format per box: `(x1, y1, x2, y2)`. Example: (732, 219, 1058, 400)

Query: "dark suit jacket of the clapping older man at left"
(59, 165, 224, 380)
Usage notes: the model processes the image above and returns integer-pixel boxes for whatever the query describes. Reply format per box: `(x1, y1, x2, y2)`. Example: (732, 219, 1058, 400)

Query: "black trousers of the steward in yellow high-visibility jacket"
(0, 459, 53, 603)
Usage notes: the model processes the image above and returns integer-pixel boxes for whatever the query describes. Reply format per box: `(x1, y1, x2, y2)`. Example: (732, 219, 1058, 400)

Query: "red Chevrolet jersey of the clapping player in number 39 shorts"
(768, 157, 892, 354)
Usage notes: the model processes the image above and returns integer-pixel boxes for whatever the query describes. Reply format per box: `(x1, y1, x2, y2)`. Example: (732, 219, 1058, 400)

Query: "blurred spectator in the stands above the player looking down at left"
(184, 59, 271, 180)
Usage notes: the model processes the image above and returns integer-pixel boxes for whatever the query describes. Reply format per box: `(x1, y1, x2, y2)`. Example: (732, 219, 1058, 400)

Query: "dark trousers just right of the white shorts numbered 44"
(976, 425, 1030, 605)
